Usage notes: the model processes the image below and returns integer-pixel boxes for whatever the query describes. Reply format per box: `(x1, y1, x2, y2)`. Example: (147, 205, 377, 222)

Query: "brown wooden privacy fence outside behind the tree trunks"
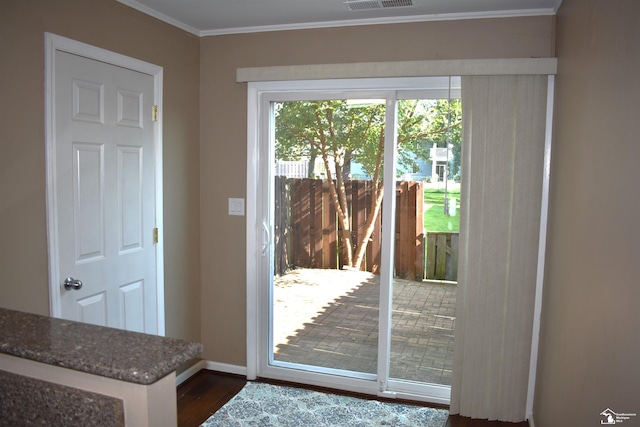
(274, 176, 458, 280)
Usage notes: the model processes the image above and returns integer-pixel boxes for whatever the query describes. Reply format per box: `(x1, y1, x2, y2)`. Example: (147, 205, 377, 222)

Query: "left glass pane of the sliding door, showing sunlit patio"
(269, 93, 385, 378)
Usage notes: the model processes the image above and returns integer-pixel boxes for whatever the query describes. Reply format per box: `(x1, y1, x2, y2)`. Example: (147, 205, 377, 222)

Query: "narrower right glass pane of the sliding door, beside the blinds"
(389, 95, 462, 400)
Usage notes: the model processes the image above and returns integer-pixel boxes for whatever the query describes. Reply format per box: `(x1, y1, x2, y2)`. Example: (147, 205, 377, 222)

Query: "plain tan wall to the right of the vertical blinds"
(534, 0, 640, 427)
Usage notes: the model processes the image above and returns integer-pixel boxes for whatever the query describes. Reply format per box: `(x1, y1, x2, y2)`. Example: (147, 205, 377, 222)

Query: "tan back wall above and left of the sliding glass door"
(200, 16, 554, 366)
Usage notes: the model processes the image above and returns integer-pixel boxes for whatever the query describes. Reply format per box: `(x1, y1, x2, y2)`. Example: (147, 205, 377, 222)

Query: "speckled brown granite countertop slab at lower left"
(0, 308, 202, 385)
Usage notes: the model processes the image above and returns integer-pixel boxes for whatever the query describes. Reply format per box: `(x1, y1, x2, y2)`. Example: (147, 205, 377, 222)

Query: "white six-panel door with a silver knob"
(53, 51, 158, 333)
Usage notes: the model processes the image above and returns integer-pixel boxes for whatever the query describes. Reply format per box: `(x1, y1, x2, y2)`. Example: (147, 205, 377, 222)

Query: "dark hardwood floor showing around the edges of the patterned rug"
(177, 370, 528, 427)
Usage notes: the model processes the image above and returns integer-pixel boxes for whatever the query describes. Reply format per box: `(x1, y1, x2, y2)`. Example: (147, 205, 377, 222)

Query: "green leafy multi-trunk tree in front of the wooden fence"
(275, 100, 459, 269)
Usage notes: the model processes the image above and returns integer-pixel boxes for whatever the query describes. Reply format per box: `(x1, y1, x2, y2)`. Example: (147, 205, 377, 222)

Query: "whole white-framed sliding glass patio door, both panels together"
(250, 77, 459, 403)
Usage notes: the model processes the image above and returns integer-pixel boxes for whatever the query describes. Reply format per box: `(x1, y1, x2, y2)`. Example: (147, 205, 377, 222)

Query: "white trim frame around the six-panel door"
(44, 33, 165, 335)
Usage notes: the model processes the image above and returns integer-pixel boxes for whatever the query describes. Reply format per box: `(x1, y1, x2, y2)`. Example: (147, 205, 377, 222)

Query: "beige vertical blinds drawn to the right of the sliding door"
(451, 75, 548, 422)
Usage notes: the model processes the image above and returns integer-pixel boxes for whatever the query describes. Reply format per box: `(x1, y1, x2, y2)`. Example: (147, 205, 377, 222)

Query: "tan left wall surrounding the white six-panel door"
(0, 0, 200, 340)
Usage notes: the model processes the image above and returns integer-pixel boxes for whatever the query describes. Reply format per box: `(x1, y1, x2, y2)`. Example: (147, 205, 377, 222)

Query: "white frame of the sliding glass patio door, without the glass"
(247, 76, 460, 404)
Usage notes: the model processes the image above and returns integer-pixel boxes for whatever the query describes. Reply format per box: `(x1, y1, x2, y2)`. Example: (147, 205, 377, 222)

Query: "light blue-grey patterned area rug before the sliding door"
(201, 382, 449, 427)
